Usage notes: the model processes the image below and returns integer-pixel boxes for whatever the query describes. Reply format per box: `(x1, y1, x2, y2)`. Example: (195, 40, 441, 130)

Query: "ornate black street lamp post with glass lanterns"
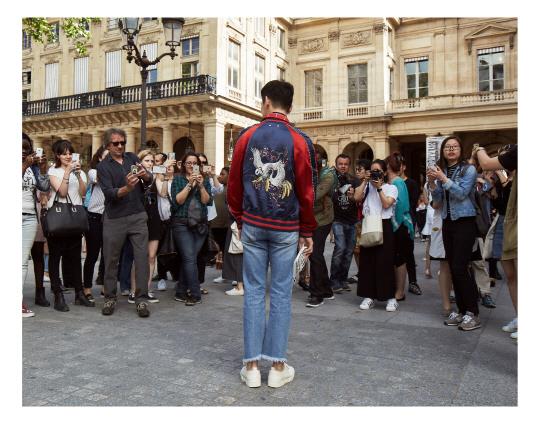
(118, 18, 185, 148)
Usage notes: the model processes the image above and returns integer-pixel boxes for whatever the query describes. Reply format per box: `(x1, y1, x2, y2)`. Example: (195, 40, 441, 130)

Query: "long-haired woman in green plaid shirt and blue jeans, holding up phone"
(171, 152, 212, 306)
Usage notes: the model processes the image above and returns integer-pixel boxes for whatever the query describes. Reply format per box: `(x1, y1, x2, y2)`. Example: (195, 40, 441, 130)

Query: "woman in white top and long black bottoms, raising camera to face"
(355, 159, 398, 311)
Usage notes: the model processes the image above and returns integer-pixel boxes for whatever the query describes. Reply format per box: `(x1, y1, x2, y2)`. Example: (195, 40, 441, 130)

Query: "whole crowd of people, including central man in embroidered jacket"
(22, 81, 517, 387)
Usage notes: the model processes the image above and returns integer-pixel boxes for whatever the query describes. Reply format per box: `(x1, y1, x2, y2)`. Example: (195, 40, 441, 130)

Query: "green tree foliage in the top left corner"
(23, 18, 101, 56)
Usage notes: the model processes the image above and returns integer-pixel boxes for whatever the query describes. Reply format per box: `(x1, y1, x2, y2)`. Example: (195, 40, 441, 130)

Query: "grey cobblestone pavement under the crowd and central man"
(22, 242, 517, 406)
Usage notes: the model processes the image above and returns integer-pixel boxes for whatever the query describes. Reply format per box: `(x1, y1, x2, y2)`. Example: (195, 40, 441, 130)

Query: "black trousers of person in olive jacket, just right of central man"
(309, 223, 333, 300)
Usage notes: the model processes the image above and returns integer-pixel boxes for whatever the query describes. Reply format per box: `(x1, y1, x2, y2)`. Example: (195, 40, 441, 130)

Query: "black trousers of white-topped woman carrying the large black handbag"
(47, 235, 82, 293)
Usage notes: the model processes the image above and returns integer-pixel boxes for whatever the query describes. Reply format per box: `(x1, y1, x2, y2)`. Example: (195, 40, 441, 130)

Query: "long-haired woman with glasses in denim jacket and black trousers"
(427, 136, 481, 331)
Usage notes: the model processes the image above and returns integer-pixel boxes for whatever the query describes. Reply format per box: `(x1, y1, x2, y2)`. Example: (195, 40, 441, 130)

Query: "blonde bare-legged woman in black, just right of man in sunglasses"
(137, 149, 161, 303)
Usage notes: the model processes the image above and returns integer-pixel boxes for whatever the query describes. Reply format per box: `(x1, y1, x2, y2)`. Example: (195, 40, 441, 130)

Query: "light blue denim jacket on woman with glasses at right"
(432, 163, 477, 221)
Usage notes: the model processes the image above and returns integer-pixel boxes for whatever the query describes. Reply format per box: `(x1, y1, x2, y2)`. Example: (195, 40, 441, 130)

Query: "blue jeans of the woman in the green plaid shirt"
(172, 221, 208, 300)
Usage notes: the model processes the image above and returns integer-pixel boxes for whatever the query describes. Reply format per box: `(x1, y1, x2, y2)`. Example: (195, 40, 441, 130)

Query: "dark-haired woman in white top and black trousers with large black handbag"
(47, 140, 94, 312)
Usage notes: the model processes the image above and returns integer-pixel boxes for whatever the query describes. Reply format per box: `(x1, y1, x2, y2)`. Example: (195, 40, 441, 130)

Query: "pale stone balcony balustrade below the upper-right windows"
(387, 89, 517, 114)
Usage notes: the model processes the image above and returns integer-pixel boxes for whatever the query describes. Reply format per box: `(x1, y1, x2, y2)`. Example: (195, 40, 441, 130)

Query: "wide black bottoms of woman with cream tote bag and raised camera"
(356, 219, 396, 301)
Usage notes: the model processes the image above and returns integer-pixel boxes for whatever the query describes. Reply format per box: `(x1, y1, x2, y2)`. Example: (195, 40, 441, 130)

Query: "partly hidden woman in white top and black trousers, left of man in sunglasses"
(83, 146, 109, 302)
